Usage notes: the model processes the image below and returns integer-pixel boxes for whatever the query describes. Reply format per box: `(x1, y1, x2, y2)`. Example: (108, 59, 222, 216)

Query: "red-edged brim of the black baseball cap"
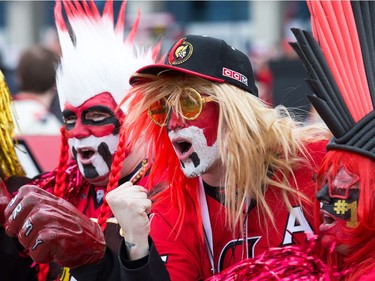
(129, 64, 225, 85)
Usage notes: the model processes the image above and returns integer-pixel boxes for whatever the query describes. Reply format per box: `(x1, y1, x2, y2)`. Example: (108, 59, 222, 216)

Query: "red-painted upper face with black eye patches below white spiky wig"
(63, 93, 124, 139)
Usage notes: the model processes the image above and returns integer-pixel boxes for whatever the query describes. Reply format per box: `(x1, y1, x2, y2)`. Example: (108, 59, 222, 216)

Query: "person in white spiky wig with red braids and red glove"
(0, 0, 159, 281)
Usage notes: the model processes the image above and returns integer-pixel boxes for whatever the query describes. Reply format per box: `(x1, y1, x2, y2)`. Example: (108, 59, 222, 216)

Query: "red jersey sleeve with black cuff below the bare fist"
(120, 209, 210, 281)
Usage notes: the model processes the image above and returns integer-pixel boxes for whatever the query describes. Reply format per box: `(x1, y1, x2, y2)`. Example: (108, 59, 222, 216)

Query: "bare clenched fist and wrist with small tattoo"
(106, 182, 151, 260)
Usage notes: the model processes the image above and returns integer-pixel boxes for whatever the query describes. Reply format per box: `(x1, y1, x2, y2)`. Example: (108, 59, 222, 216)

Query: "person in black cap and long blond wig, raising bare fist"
(106, 35, 330, 280)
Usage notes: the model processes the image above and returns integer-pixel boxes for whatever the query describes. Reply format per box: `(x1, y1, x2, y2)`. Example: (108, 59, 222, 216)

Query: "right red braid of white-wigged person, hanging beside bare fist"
(98, 121, 126, 232)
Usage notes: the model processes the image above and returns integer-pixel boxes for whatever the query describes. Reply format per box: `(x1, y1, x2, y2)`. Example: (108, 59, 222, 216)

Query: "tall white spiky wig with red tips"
(55, 1, 157, 111)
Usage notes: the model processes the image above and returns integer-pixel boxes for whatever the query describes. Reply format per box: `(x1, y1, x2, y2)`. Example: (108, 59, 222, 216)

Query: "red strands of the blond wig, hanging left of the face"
(120, 89, 204, 239)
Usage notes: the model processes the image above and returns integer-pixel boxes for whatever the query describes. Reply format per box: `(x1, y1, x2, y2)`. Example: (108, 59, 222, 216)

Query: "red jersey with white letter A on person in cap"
(151, 141, 326, 280)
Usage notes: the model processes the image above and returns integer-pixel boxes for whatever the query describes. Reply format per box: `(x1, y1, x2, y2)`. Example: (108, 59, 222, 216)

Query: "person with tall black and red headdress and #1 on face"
(292, 1, 375, 281)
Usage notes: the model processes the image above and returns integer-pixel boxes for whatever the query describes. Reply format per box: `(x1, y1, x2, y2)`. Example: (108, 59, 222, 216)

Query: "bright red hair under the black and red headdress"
(318, 150, 375, 281)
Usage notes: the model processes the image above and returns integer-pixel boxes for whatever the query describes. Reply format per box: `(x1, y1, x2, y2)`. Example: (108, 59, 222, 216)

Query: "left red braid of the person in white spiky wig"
(52, 126, 69, 198)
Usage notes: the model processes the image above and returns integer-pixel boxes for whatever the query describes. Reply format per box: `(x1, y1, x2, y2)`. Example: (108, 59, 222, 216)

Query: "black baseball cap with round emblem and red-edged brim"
(130, 35, 258, 96)
